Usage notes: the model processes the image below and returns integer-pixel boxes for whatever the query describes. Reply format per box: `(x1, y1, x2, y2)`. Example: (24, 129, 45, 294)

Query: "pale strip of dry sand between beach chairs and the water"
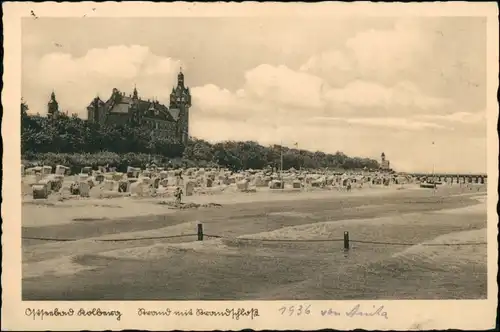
(23, 182, 420, 227)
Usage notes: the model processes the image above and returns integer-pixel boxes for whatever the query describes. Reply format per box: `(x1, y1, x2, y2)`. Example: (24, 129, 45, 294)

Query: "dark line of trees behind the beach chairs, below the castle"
(21, 102, 379, 171)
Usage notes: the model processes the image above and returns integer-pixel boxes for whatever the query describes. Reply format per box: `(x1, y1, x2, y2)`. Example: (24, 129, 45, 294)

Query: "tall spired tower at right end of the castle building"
(170, 68, 191, 144)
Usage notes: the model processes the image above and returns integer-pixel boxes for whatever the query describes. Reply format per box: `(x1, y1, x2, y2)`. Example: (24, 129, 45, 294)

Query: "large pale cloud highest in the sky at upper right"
(300, 18, 442, 86)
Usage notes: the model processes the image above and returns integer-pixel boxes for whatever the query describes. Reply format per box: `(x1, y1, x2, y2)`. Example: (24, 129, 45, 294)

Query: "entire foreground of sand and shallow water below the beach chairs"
(23, 186, 486, 300)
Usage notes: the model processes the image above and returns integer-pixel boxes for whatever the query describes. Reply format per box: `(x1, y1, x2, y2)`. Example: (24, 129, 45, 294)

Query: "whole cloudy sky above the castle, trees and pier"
(22, 17, 487, 172)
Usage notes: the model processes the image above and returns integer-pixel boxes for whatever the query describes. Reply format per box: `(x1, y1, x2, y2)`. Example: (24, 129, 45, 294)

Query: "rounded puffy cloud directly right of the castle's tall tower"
(192, 64, 327, 124)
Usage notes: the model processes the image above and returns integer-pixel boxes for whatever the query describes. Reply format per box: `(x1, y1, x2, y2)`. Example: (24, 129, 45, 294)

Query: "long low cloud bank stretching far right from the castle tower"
(192, 65, 450, 127)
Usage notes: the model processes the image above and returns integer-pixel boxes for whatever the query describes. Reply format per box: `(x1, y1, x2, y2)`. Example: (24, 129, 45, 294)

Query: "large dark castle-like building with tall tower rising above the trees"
(87, 69, 191, 144)
